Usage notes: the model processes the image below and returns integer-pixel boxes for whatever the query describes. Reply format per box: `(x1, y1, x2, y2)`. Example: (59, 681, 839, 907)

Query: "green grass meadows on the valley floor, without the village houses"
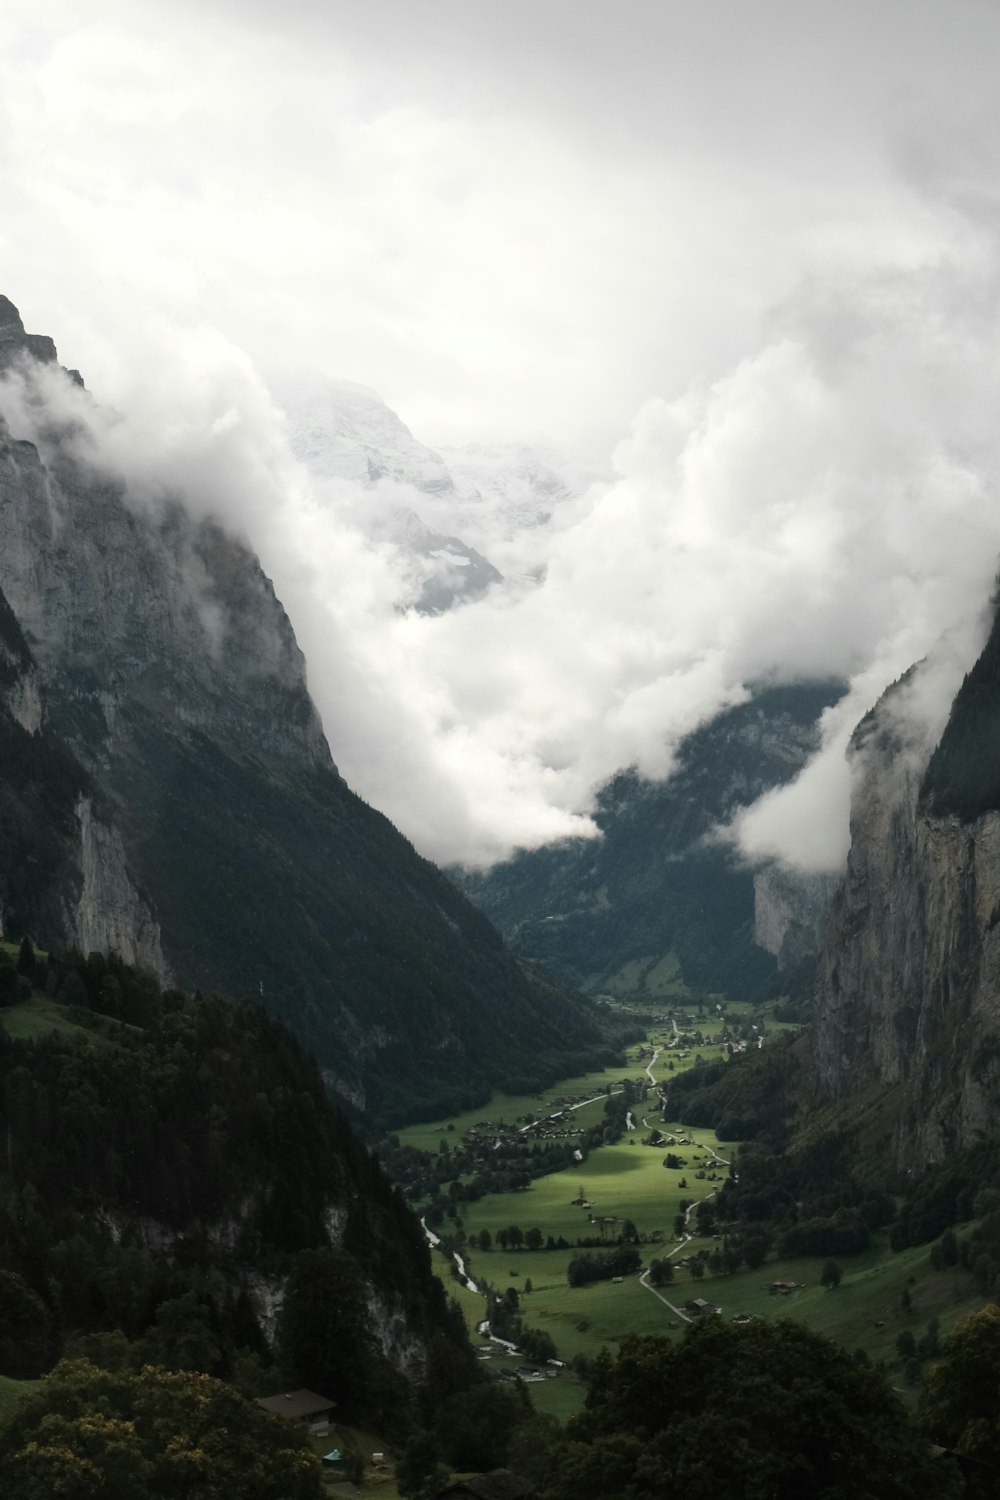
(399, 1004, 984, 1419)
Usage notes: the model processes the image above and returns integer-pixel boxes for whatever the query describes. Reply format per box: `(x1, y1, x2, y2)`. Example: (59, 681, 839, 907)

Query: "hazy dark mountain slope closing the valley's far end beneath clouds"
(456, 683, 841, 999)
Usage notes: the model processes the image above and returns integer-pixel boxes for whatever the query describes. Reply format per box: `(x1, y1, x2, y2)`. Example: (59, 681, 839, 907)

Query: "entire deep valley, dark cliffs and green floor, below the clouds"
(0, 289, 1000, 1500)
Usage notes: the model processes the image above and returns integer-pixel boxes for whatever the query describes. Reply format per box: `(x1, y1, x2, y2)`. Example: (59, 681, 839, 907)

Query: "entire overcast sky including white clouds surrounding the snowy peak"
(0, 0, 1000, 867)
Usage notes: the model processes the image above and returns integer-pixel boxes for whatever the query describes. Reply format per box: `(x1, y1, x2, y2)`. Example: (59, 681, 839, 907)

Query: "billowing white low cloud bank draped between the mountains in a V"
(0, 189, 1000, 870)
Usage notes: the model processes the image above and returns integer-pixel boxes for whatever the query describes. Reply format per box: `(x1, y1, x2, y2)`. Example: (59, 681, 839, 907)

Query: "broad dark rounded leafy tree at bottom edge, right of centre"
(540, 1319, 960, 1500)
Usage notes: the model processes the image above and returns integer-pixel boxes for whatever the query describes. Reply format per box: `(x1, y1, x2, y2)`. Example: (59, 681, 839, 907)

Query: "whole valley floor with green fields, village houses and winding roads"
(387, 995, 987, 1421)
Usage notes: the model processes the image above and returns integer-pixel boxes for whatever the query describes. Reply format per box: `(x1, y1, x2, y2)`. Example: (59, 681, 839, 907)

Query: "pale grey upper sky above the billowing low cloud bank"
(0, 0, 983, 446)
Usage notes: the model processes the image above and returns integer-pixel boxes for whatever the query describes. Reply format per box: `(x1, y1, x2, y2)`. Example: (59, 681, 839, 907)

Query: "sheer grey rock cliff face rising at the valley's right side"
(813, 639, 1000, 1167)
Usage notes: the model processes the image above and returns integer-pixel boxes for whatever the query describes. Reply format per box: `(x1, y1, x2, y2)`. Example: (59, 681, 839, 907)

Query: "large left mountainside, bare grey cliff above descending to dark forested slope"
(0, 295, 603, 1121)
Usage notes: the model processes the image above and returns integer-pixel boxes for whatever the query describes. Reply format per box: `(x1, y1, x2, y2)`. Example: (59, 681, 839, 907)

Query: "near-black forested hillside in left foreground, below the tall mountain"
(0, 944, 479, 1425)
